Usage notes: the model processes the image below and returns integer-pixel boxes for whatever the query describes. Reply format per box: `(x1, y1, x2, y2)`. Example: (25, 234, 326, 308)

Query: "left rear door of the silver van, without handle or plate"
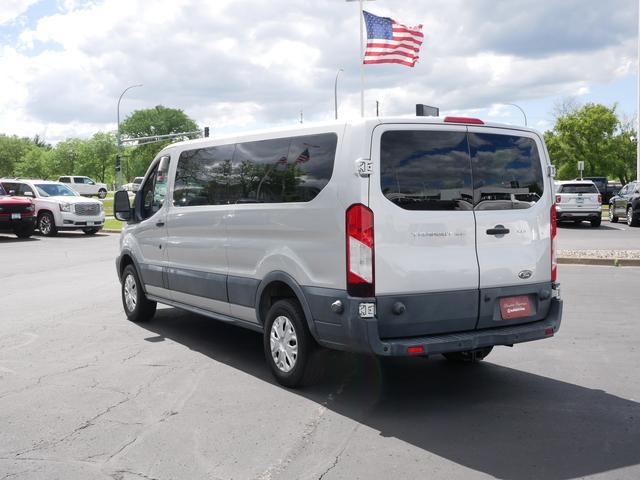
(369, 124, 479, 338)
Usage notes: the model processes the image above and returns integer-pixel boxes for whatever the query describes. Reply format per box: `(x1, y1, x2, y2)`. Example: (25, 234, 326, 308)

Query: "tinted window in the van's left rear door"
(380, 130, 473, 210)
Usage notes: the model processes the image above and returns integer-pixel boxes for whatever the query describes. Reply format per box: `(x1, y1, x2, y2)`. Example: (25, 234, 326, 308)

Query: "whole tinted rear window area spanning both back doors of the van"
(380, 130, 544, 210)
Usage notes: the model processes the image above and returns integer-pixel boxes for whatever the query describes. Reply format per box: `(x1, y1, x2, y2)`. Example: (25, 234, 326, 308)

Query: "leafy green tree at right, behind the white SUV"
(545, 103, 635, 183)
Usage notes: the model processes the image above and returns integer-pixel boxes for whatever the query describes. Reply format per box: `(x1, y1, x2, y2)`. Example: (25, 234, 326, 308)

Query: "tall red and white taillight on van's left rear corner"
(346, 203, 375, 297)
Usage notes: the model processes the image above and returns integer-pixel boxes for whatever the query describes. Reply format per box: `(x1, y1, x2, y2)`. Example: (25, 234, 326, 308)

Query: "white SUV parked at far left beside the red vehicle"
(0, 179, 104, 236)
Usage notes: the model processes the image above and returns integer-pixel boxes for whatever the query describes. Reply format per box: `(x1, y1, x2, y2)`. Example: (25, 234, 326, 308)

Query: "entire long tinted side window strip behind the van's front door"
(173, 133, 338, 206)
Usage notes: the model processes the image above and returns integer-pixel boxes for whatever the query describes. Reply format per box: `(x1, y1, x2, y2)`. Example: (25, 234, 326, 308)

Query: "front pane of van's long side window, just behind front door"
(173, 145, 235, 207)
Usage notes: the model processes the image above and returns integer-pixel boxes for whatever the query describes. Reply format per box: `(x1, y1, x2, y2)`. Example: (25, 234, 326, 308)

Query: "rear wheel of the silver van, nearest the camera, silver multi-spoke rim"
(264, 299, 320, 388)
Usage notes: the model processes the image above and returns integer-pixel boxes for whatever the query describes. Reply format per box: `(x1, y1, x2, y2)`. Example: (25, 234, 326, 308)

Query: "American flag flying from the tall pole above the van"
(363, 12, 424, 67)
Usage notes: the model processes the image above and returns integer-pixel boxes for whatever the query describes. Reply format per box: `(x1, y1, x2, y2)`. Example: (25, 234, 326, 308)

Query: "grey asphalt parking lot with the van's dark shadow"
(0, 233, 640, 480)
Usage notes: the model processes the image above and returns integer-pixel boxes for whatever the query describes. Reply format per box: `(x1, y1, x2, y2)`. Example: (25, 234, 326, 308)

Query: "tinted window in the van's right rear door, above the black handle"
(469, 133, 544, 210)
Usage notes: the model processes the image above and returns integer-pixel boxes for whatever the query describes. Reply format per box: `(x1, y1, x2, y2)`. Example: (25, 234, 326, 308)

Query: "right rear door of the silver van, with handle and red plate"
(468, 127, 553, 328)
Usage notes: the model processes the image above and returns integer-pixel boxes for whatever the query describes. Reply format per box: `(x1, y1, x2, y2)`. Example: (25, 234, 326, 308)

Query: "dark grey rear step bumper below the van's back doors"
(366, 299, 562, 356)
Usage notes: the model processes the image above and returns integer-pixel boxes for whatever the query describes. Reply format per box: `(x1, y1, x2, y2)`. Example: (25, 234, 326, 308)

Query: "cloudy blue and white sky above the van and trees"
(0, 0, 638, 143)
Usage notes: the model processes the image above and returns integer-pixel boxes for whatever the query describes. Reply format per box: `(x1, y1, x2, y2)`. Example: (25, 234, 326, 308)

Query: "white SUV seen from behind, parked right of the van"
(556, 180, 602, 227)
